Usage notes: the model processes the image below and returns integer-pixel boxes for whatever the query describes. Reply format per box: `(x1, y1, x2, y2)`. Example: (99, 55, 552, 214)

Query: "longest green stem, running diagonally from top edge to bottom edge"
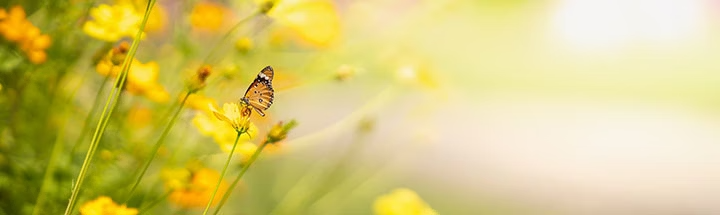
(65, 0, 155, 215)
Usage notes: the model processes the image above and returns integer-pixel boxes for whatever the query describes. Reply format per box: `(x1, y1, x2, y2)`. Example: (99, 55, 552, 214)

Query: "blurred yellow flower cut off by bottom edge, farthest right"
(373, 188, 438, 215)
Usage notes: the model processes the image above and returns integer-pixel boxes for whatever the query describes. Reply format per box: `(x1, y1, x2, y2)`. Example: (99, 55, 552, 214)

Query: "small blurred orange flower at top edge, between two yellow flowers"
(190, 2, 226, 31)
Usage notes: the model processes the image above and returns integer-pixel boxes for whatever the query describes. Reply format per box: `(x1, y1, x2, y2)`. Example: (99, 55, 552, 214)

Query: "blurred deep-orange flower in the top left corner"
(0, 6, 51, 64)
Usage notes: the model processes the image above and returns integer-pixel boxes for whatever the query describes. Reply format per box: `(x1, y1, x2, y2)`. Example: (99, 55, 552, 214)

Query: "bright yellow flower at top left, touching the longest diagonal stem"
(83, 3, 143, 42)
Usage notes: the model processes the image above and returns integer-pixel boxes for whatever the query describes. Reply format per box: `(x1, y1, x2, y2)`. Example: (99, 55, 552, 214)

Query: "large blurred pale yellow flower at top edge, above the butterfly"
(263, 0, 340, 47)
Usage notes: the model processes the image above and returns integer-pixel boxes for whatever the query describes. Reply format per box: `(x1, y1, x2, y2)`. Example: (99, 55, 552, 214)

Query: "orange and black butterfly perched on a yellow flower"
(240, 66, 275, 116)
